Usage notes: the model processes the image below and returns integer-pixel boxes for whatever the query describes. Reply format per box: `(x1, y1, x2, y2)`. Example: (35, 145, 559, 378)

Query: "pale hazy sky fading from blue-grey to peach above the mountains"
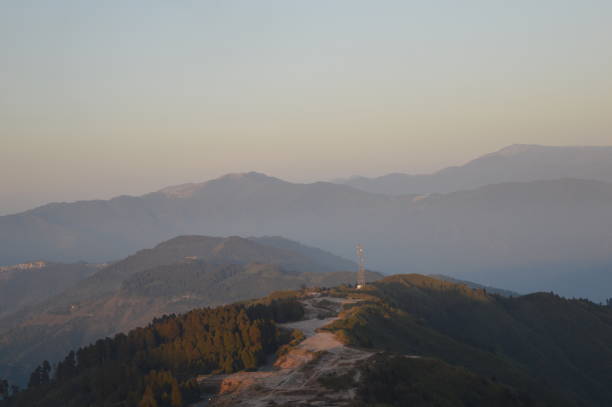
(0, 0, 612, 214)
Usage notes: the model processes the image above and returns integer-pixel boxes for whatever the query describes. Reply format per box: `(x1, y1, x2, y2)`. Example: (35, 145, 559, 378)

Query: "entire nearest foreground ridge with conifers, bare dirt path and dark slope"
(4, 274, 612, 407)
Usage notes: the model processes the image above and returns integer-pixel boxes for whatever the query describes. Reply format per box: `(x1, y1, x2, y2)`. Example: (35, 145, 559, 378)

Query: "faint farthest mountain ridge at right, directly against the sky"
(334, 144, 612, 195)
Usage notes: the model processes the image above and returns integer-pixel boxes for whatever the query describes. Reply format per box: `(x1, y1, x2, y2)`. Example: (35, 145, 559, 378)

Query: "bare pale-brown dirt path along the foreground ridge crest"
(209, 296, 373, 407)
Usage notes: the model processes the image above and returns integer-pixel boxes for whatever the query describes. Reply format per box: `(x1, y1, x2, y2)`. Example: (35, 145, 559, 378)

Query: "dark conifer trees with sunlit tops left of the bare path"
(6, 298, 304, 407)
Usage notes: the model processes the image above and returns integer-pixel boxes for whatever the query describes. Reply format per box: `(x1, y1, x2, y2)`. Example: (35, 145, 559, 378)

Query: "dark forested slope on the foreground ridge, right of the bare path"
(329, 275, 612, 407)
